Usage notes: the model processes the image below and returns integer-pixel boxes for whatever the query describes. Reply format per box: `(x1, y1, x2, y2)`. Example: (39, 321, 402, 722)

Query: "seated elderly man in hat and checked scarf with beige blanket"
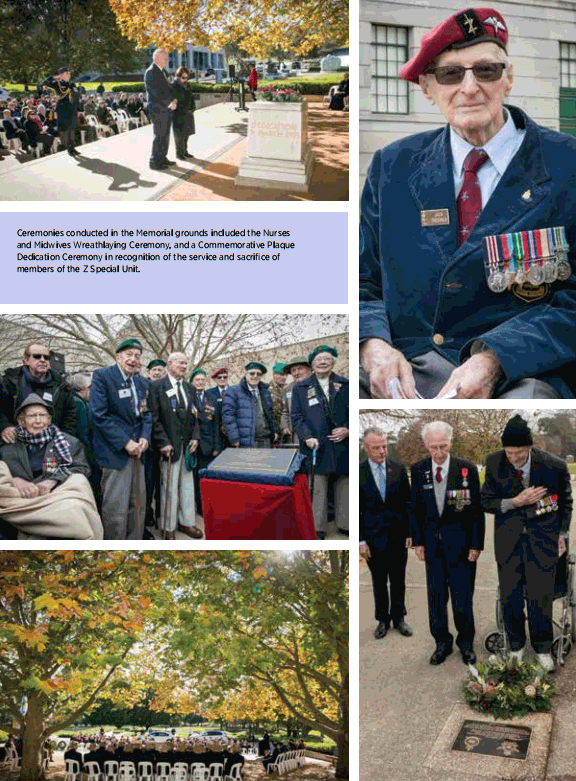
(0, 393, 103, 540)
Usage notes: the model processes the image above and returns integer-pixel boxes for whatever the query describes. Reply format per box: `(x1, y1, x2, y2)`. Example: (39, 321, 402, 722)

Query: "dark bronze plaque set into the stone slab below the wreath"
(452, 721, 532, 759)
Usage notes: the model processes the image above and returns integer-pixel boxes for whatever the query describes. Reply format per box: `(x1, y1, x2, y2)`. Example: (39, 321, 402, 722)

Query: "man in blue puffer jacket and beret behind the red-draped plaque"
(222, 361, 278, 448)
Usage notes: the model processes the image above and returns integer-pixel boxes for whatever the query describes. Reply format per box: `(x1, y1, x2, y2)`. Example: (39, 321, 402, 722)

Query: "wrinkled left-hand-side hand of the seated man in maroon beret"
(360, 339, 416, 399)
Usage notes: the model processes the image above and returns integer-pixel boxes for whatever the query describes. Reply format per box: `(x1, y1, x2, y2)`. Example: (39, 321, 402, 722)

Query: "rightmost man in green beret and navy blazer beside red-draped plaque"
(292, 345, 349, 540)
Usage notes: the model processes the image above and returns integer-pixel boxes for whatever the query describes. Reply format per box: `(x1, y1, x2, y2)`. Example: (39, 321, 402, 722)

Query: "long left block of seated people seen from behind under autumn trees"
(64, 737, 244, 778)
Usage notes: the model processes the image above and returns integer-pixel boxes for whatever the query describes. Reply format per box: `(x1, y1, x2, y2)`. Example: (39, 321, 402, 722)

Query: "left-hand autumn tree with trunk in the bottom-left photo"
(0, 551, 162, 781)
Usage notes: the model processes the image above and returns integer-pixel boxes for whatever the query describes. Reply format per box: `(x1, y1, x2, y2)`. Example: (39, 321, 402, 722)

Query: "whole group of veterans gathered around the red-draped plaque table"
(0, 338, 348, 540)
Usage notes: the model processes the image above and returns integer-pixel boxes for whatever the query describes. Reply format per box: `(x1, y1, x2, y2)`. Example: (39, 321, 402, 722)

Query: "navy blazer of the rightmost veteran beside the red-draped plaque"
(291, 373, 350, 475)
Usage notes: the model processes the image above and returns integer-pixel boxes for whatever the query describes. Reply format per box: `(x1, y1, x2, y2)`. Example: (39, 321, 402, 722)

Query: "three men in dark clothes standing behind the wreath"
(360, 415, 572, 670)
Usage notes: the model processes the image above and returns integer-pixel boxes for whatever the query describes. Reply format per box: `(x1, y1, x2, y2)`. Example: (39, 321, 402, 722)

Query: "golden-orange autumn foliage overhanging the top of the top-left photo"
(110, 0, 349, 58)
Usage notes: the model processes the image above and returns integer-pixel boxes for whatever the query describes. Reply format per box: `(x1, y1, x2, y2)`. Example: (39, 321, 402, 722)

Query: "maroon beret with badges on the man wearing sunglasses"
(399, 8, 508, 84)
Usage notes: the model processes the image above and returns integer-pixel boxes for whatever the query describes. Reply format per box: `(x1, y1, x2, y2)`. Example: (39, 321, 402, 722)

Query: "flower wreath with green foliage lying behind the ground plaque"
(464, 655, 556, 719)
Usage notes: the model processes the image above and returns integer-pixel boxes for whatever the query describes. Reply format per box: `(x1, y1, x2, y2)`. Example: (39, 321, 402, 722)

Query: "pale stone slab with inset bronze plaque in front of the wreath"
(424, 704, 554, 781)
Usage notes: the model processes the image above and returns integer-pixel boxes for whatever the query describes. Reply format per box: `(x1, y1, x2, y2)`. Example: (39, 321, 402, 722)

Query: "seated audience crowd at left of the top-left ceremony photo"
(0, 79, 148, 157)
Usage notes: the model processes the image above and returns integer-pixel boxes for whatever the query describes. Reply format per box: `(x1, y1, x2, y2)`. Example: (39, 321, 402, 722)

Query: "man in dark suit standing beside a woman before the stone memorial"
(144, 49, 177, 171)
